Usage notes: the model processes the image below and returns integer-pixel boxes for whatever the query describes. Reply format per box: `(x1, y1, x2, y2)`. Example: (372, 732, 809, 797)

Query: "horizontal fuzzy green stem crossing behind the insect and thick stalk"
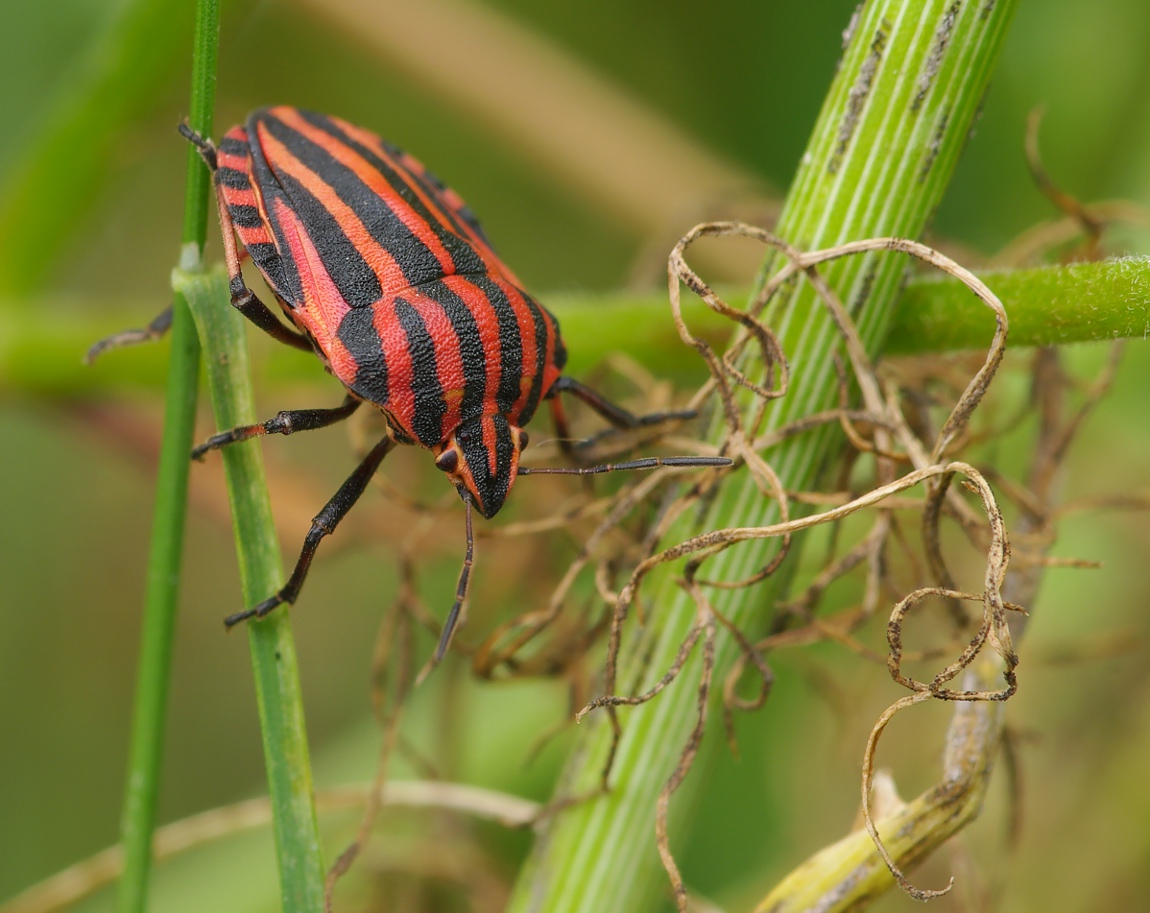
(0, 256, 1150, 397)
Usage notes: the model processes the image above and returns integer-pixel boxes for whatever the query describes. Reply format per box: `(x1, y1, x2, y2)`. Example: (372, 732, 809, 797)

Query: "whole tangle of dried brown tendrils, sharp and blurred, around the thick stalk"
(352, 222, 1113, 910)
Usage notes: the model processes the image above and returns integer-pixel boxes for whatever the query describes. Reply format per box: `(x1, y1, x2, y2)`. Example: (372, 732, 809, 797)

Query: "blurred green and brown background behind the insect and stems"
(0, 0, 1150, 911)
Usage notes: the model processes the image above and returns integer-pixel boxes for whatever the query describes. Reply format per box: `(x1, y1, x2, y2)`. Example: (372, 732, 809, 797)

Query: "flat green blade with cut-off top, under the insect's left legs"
(173, 264, 323, 913)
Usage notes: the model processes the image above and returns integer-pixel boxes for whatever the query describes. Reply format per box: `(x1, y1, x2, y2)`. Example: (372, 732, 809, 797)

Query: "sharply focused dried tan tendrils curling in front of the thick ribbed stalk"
(578, 222, 1018, 910)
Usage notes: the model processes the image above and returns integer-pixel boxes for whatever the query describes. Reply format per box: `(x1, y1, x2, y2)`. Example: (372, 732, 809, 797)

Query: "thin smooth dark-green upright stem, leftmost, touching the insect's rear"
(116, 0, 220, 913)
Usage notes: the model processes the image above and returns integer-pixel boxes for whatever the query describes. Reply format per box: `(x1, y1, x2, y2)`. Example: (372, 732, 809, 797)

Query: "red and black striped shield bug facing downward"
(181, 107, 730, 661)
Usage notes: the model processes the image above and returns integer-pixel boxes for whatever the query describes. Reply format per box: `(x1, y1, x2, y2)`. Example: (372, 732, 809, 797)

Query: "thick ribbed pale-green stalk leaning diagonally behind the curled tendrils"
(508, 0, 1015, 913)
